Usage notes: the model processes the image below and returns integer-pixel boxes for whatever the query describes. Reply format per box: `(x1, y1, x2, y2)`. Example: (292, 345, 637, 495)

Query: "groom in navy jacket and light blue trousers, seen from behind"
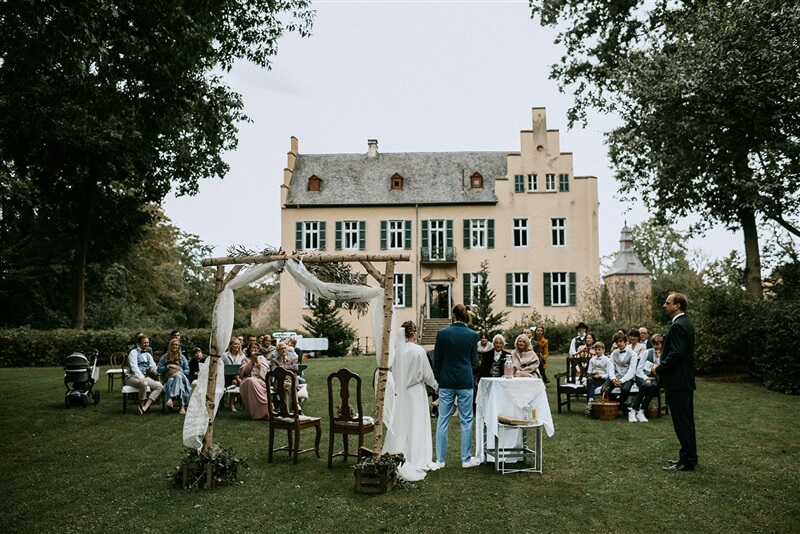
(433, 304, 481, 469)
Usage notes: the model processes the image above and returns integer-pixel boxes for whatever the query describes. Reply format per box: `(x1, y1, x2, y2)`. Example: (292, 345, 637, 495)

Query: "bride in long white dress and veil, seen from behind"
(383, 321, 439, 482)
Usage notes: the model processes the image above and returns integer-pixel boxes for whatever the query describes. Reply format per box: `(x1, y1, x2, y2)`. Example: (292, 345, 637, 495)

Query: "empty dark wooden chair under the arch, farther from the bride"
(267, 367, 322, 464)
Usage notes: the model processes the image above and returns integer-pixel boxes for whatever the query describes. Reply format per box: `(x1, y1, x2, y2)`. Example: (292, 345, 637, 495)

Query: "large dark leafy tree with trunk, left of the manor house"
(0, 0, 313, 328)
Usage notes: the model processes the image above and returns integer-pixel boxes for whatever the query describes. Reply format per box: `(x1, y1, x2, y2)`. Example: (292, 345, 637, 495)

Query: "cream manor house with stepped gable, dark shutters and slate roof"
(280, 108, 600, 348)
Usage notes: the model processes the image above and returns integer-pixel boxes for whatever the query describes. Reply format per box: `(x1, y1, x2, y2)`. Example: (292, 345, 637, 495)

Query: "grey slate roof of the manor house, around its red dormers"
(286, 152, 508, 207)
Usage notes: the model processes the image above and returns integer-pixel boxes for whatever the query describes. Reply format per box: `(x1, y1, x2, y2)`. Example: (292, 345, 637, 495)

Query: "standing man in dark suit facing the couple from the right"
(653, 293, 697, 471)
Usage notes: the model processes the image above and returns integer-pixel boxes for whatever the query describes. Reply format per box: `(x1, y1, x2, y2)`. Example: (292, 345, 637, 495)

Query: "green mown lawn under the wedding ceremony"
(0, 357, 800, 533)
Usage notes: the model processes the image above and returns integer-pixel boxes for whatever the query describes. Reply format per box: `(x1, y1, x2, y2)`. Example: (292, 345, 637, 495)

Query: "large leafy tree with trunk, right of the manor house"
(534, 0, 800, 300)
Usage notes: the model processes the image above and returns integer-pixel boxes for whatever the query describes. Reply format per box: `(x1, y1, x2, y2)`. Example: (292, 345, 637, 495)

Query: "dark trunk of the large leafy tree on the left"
(72, 170, 97, 330)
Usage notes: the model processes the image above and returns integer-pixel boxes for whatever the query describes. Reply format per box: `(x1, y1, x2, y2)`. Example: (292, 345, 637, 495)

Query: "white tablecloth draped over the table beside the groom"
(475, 378, 555, 461)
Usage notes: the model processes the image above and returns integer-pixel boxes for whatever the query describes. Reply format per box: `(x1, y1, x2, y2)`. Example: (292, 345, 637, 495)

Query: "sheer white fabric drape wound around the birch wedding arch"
(183, 259, 396, 451)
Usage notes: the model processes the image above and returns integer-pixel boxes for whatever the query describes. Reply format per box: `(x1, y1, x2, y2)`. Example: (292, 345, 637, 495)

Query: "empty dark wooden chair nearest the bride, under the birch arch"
(328, 369, 375, 467)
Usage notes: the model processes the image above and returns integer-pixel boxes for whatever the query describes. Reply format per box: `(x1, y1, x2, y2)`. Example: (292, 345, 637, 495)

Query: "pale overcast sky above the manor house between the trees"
(164, 0, 743, 268)
